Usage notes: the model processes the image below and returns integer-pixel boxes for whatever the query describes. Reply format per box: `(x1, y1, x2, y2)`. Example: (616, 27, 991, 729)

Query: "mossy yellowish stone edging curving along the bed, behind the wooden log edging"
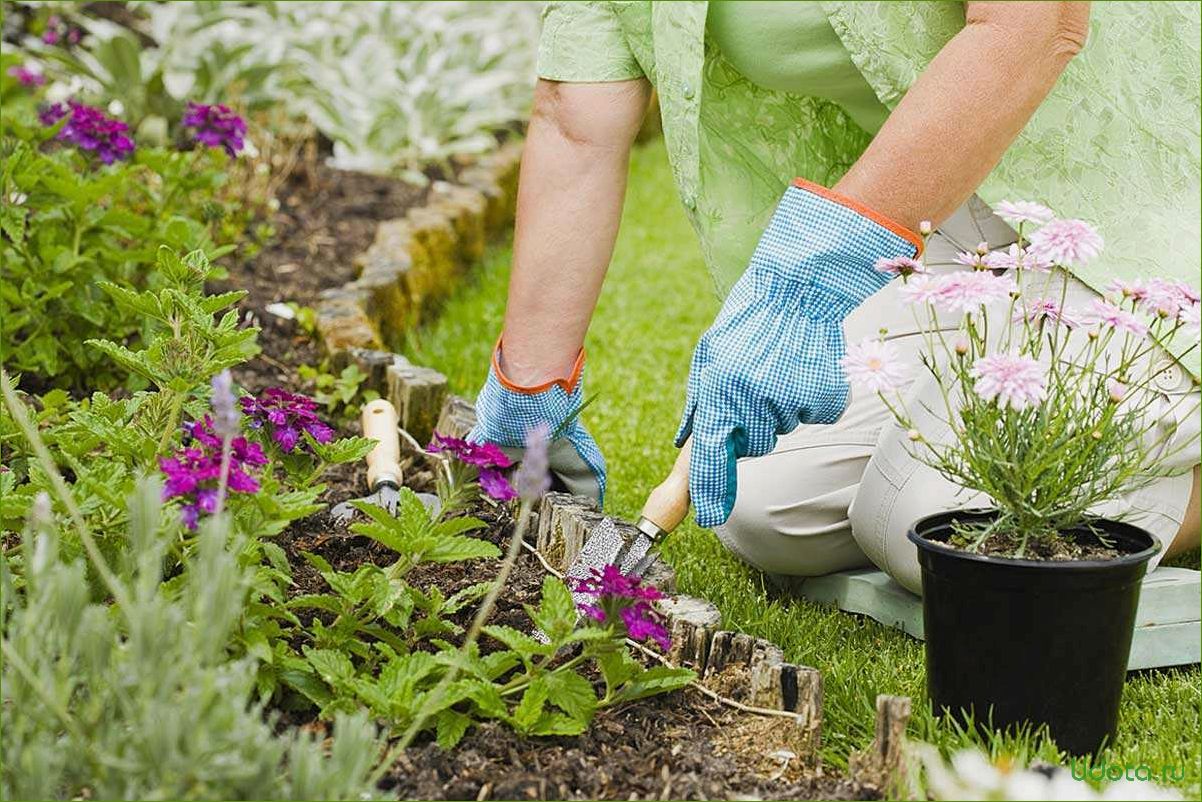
(317, 139, 522, 354)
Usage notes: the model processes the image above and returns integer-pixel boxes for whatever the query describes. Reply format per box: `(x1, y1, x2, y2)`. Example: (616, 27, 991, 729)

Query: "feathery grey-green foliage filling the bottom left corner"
(0, 480, 380, 800)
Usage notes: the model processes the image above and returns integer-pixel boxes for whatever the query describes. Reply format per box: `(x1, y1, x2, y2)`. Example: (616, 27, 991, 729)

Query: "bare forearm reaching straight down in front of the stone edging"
(501, 79, 650, 385)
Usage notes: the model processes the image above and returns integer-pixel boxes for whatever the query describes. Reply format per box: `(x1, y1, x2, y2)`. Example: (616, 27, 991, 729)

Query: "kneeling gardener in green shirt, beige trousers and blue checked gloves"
(463, 2, 1200, 592)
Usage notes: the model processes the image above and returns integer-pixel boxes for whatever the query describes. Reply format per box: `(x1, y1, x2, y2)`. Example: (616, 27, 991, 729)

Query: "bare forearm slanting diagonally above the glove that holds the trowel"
(835, 0, 1089, 228)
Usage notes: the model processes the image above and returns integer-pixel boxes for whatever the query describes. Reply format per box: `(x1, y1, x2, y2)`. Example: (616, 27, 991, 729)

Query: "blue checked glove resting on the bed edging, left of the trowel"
(468, 340, 606, 503)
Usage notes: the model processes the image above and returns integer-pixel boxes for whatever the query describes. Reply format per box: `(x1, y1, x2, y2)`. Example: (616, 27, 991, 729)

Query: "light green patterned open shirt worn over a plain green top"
(538, 0, 1202, 374)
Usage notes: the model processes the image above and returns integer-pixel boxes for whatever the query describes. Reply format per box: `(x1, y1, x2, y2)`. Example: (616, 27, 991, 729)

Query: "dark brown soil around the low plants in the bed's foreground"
(278, 492, 879, 800)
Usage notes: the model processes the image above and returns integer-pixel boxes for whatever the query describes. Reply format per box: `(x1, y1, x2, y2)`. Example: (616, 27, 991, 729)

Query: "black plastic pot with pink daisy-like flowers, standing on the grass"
(843, 203, 1200, 754)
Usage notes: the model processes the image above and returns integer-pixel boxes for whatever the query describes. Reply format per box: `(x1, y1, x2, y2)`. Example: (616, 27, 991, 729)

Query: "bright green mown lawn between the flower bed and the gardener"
(406, 143, 1202, 789)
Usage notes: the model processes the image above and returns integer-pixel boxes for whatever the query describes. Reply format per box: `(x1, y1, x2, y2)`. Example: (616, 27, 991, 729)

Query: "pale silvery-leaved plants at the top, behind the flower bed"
(137, 2, 538, 183)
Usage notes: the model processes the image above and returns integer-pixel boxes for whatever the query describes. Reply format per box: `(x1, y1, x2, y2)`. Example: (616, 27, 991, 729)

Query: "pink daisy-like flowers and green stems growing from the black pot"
(843, 202, 1200, 557)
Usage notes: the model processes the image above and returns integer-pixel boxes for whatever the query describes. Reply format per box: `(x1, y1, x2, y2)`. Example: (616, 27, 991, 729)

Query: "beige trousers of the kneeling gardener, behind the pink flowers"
(716, 197, 1200, 593)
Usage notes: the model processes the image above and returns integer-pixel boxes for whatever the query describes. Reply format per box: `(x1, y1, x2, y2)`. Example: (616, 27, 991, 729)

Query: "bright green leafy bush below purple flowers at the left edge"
(0, 109, 244, 388)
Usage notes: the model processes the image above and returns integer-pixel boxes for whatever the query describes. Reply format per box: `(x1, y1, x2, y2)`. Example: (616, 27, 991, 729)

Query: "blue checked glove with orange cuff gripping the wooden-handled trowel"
(677, 179, 922, 527)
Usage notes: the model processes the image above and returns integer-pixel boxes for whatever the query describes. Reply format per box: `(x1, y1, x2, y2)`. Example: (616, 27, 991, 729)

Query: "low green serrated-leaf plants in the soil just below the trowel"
(261, 489, 694, 748)
